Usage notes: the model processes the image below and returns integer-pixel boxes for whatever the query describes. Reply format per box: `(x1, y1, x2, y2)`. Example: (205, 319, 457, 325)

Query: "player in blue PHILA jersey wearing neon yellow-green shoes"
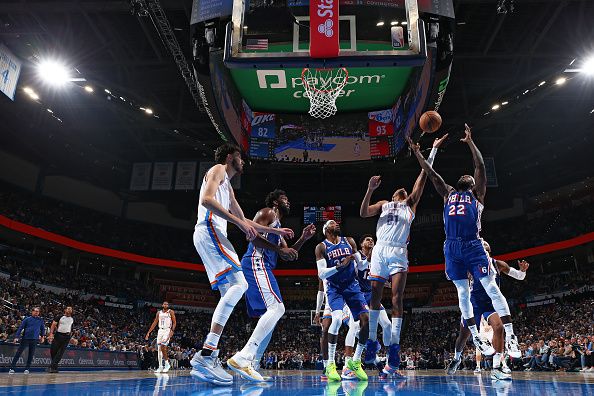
(316, 220, 369, 381)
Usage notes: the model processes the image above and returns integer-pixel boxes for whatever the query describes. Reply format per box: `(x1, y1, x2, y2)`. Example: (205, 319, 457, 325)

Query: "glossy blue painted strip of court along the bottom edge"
(0, 373, 593, 396)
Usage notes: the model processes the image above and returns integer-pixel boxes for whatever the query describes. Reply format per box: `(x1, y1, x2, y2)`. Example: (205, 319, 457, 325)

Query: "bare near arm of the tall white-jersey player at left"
(200, 164, 257, 240)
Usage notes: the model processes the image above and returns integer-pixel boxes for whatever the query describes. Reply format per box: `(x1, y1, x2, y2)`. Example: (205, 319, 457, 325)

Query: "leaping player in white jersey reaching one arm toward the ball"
(360, 134, 448, 376)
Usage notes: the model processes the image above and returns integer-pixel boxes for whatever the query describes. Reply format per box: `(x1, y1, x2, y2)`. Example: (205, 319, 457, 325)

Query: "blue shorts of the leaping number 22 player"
(442, 239, 491, 281)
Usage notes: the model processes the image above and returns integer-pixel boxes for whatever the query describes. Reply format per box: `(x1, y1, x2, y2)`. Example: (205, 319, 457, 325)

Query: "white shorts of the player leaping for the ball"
(367, 241, 408, 282)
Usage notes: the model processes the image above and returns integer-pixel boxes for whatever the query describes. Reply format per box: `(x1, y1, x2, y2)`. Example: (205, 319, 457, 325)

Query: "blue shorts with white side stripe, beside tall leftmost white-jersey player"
(241, 256, 283, 318)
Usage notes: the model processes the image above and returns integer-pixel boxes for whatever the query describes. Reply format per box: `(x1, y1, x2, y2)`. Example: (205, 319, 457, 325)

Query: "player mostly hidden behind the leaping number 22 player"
(447, 241, 530, 380)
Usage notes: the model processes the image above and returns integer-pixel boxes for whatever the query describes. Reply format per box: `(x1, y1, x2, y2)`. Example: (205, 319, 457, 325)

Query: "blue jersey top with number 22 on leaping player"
(443, 191, 484, 241)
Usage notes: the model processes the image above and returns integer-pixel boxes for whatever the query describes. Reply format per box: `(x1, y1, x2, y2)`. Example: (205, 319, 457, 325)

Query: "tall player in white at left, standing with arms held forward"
(190, 143, 297, 385)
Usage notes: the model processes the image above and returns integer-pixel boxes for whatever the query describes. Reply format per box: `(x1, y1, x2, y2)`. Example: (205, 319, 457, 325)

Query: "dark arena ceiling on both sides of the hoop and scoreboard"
(0, 0, 594, 209)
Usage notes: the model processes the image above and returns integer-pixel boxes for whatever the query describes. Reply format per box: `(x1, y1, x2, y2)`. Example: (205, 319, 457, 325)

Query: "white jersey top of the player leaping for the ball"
(375, 201, 415, 247)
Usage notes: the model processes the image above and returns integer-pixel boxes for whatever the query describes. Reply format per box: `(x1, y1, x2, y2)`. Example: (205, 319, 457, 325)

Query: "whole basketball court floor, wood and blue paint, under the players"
(0, 370, 594, 396)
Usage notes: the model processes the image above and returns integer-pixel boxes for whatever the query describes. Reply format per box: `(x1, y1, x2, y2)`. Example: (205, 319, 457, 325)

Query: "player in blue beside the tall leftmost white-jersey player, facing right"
(227, 189, 316, 381)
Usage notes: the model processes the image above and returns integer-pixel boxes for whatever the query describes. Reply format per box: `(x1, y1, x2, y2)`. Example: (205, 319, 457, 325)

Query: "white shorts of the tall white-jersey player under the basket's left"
(194, 222, 241, 290)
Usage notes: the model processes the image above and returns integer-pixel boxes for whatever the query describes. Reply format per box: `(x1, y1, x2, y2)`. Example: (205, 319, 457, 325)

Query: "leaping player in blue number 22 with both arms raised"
(408, 125, 519, 355)
